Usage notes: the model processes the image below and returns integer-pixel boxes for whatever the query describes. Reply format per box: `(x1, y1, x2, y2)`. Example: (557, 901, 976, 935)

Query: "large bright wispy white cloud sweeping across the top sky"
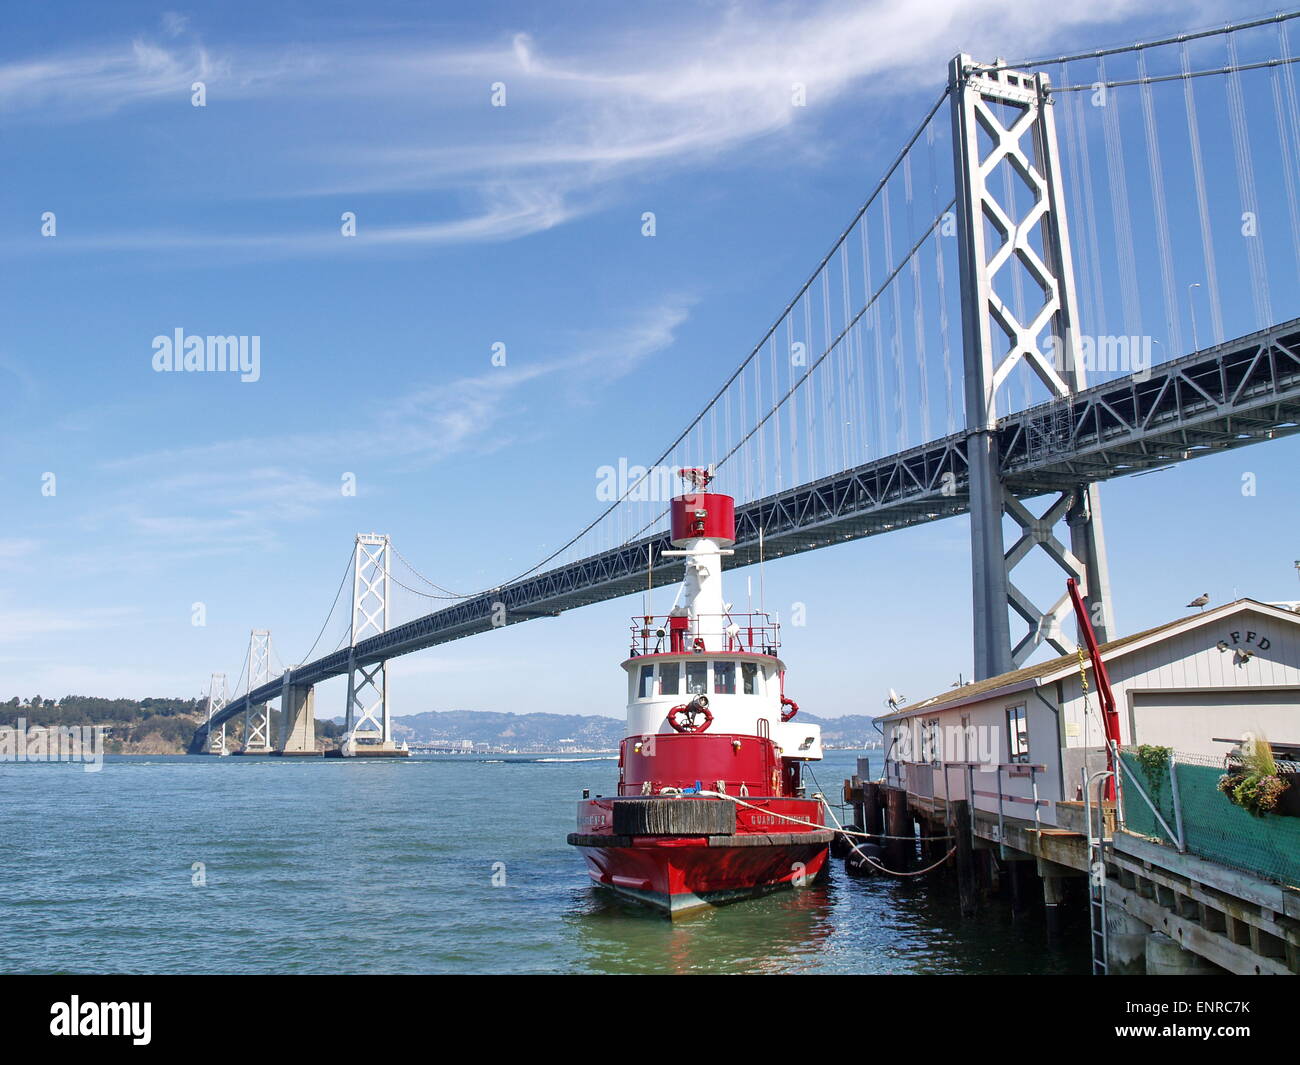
(0, 0, 1186, 255)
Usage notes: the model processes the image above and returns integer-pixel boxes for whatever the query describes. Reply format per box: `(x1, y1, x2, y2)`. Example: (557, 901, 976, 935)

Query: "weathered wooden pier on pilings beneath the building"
(844, 763, 1300, 975)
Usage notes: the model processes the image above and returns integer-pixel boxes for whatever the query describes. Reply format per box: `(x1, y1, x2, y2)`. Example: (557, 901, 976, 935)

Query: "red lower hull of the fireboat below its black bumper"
(568, 831, 832, 918)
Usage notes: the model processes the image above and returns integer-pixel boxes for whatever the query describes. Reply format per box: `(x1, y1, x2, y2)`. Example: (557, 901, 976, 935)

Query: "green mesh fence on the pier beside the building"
(1119, 750, 1300, 887)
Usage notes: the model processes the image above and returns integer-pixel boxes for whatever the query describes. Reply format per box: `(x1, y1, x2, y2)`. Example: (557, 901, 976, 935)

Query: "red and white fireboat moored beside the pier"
(568, 469, 833, 917)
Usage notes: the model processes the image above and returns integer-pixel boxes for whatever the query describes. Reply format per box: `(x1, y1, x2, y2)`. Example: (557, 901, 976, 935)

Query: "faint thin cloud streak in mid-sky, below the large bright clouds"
(89, 296, 690, 546)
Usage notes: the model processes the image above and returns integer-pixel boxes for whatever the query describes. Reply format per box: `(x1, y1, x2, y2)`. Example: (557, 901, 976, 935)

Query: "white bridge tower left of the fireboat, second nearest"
(343, 533, 406, 757)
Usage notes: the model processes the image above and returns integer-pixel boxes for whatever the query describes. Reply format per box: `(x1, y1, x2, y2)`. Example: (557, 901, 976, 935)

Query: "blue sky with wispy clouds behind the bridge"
(0, 0, 1300, 717)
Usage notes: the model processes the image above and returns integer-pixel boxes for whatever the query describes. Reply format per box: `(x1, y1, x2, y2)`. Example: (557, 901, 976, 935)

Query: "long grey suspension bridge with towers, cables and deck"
(191, 12, 1300, 754)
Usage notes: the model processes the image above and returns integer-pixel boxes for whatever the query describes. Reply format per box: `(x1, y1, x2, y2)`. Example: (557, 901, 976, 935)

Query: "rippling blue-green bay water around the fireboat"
(0, 752, 1087, 973)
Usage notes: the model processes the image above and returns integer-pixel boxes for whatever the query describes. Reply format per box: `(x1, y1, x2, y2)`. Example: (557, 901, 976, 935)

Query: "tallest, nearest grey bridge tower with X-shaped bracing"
(949, 55, 1114, 680)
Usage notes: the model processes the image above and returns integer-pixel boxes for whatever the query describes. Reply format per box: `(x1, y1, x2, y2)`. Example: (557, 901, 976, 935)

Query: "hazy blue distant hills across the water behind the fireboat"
(393, 710, 879, 750)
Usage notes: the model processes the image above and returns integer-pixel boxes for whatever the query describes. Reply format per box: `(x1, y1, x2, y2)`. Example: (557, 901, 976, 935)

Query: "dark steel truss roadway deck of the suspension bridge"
(192, 319, 1300, 750)
